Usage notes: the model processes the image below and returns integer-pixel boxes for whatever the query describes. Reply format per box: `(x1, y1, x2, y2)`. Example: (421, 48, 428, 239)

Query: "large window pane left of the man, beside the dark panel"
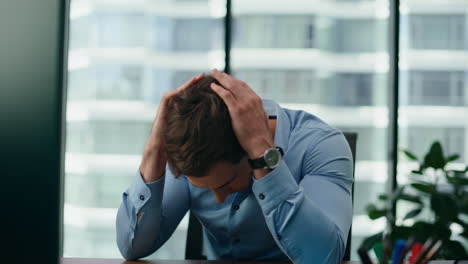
(63, 0, 224, 259)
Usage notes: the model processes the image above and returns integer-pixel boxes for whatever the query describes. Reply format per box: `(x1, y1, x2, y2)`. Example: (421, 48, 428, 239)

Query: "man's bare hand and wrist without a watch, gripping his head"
(140, 74, 203, 182)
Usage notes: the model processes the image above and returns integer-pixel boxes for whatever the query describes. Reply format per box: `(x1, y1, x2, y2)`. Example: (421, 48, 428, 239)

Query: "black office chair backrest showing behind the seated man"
(185, 132, 357, 261)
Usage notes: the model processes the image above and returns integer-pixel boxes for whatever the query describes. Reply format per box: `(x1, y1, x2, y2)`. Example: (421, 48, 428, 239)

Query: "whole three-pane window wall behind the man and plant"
(64, 0, 468, 260)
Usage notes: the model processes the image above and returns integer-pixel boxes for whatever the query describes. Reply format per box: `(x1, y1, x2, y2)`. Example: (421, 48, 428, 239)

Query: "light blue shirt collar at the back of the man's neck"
(263, 99, 291, 152)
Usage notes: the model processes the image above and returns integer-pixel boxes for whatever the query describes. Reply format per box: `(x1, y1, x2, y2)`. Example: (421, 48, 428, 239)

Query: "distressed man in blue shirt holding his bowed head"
(117, 69, 353, 263)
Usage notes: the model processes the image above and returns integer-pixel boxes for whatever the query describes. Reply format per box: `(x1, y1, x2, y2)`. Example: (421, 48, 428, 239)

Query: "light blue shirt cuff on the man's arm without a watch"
(127, 169, 166, 211)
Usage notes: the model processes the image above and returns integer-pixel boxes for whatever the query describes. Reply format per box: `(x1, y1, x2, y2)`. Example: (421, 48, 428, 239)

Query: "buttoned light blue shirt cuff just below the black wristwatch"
(252, 160, 299, 214)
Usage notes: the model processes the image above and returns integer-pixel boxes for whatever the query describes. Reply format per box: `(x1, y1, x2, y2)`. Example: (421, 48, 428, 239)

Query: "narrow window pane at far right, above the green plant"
(399, 0, 468, 174)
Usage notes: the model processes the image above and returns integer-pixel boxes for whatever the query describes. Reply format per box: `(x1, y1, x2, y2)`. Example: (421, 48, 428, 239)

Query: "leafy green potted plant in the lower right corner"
(361, 141, 468, 259)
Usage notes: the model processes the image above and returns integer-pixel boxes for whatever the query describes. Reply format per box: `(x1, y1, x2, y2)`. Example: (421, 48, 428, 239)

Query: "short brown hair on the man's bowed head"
(164, 75, 245, 177)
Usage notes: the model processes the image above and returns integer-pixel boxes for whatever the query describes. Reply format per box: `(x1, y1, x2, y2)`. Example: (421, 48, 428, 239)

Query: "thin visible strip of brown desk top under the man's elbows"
(61, 258, 453, 264)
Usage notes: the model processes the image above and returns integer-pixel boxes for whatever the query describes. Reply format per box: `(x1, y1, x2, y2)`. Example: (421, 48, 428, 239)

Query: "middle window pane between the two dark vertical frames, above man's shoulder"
(232, 1, 388, 259)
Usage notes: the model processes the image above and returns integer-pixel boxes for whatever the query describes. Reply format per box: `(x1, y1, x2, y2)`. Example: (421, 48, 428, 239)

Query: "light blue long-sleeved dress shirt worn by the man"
(116, 100, 353, 264)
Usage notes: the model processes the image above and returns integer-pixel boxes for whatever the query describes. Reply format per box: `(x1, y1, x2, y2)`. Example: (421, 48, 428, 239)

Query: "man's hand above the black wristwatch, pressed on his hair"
(211, 69, 274, 162)
